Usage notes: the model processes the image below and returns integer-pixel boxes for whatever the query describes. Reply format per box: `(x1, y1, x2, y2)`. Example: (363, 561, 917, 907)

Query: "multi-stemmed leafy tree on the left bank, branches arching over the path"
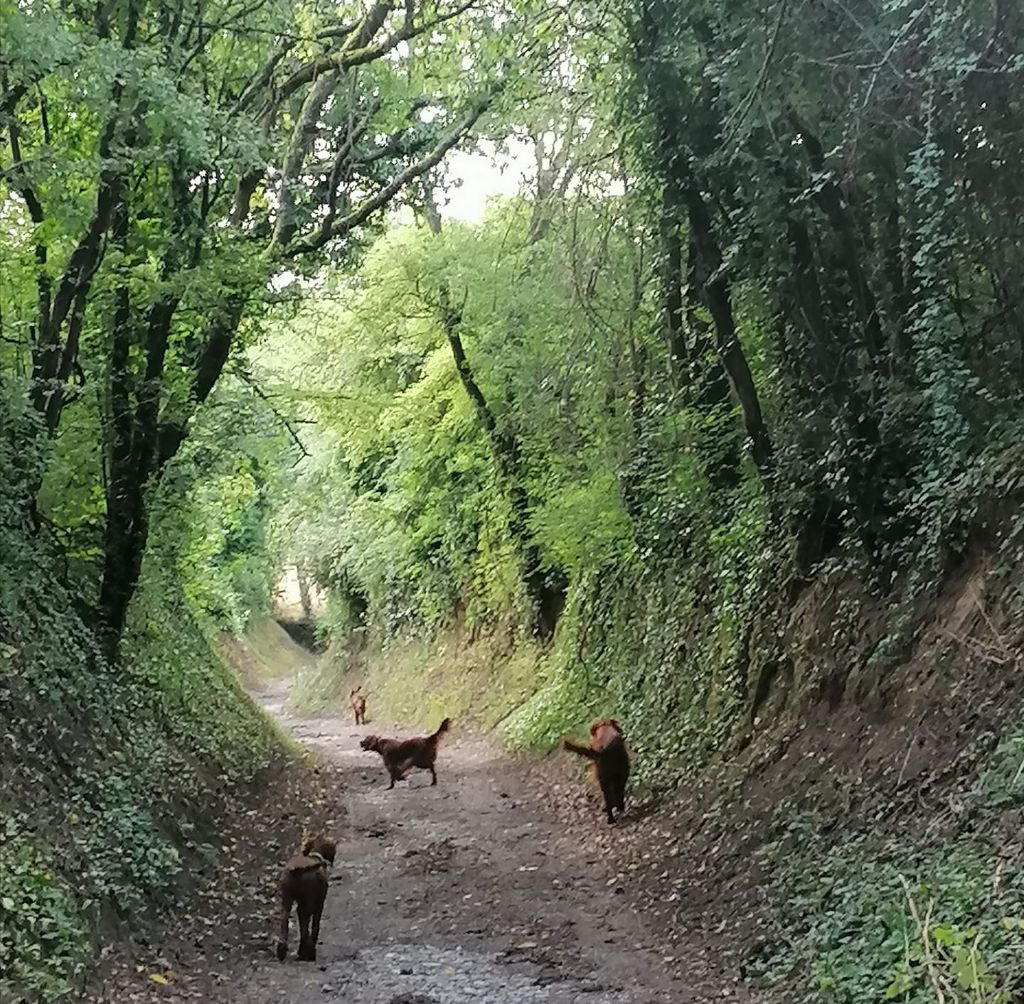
(2, 0, 544, 655)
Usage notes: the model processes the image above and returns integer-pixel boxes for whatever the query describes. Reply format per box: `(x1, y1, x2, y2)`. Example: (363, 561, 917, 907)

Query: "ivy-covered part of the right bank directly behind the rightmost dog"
(503, 487, 769, 791)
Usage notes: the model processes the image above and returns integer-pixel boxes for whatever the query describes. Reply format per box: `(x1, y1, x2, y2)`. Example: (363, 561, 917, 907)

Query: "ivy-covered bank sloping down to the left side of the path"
(0, 422, 281, 1004)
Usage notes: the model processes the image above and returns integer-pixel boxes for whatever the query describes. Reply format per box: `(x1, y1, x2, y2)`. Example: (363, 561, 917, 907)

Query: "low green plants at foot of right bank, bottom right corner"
(759, 818, 1024, 1004)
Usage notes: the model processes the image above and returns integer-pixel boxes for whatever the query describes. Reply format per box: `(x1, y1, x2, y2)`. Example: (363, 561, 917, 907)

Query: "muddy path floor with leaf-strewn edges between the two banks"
(84, 689, 750, 1004)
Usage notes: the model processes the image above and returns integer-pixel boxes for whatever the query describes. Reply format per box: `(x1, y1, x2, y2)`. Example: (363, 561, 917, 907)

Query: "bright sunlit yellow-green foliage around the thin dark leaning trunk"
(257, 193, 651, 632)
